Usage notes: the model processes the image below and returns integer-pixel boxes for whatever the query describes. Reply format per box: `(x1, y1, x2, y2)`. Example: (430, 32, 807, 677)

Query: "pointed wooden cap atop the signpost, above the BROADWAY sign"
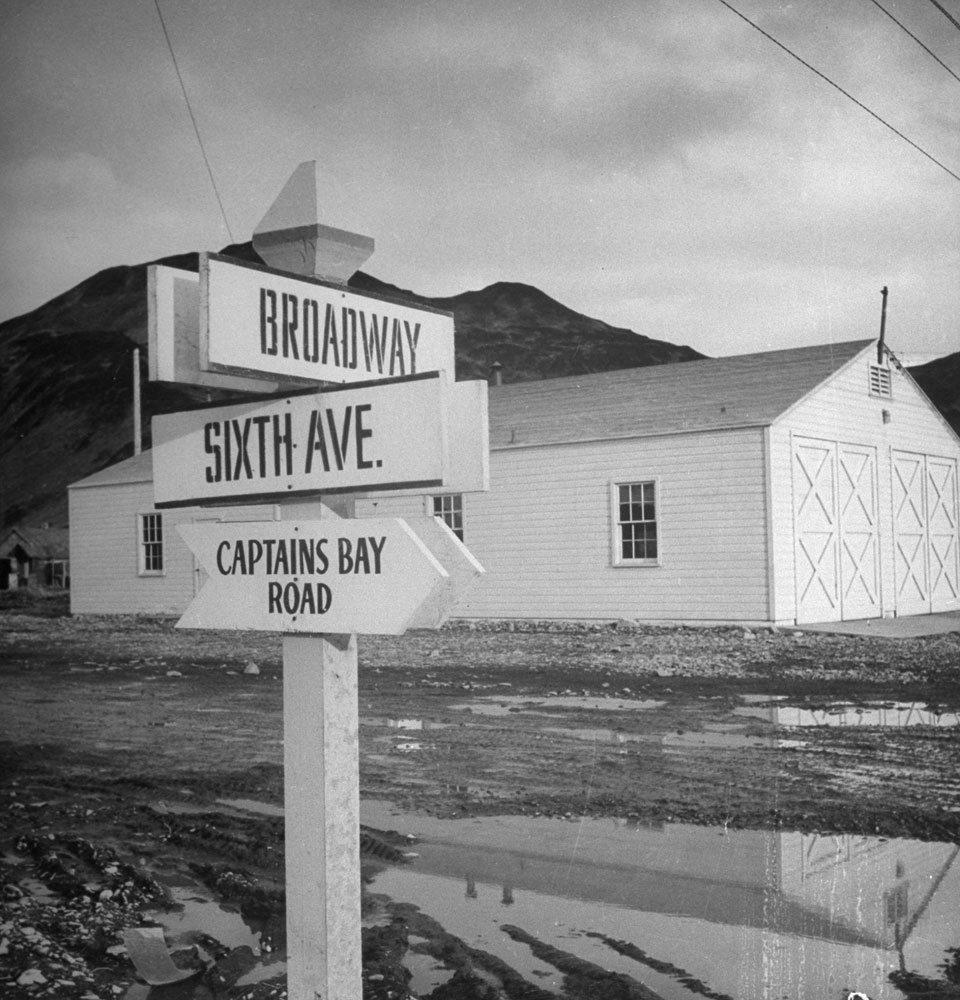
(253, 160, 374, 284)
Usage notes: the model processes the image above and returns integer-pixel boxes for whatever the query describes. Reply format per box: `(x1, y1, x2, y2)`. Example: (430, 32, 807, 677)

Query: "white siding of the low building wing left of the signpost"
(68, 482, 273, 615)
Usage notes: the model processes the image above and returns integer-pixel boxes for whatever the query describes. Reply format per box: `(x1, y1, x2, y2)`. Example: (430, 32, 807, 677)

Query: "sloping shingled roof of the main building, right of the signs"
(490, 340, 875, 448)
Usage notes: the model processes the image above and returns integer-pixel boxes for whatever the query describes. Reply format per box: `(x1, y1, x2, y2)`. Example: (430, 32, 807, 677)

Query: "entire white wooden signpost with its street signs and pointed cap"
(149, 163, 489, 1000)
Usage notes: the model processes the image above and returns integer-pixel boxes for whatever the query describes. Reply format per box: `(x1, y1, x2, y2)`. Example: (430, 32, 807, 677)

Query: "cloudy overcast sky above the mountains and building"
(0, 0, 960, 355)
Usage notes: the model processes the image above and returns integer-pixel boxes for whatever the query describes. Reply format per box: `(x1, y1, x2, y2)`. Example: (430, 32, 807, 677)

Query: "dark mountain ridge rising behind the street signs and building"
(0, 243, 702, 529)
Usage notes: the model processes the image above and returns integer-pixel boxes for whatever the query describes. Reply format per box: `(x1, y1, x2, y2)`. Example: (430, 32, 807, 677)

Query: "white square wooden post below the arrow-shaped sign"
(283, 635, 363, 1000)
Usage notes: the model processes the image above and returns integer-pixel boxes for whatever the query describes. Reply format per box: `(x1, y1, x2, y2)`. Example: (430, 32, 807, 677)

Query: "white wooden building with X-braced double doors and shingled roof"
(70, 341, 960, 623)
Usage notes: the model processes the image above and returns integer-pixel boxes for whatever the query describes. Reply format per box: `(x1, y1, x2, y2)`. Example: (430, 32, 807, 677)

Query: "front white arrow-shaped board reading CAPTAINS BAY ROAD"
(177, 518, 447, 635)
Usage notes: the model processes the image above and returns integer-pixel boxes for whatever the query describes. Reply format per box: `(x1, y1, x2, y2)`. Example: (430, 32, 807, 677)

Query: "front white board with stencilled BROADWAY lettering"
(199, 254, 454, 383)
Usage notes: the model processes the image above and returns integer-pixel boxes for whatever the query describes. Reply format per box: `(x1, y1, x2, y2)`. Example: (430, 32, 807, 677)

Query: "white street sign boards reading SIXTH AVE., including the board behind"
(152, 372, 489, 508)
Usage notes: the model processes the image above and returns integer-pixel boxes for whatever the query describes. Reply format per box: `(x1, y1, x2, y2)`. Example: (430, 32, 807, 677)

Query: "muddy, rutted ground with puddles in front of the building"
(0, 604, 960, 1000)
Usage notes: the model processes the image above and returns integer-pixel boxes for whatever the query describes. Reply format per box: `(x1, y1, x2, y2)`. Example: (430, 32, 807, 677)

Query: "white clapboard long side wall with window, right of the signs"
(357, 428, 768, 621)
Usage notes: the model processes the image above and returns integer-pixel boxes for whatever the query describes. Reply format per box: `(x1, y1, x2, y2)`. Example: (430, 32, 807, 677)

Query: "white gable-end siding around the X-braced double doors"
(770, 346, 960, 622)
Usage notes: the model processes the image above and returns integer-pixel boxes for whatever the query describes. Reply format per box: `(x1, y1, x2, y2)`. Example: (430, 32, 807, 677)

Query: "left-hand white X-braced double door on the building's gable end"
(792, 437, 881, 622)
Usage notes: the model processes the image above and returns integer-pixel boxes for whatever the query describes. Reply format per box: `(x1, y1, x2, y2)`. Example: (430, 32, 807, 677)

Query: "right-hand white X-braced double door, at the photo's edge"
(890, 451, 960, 615)
